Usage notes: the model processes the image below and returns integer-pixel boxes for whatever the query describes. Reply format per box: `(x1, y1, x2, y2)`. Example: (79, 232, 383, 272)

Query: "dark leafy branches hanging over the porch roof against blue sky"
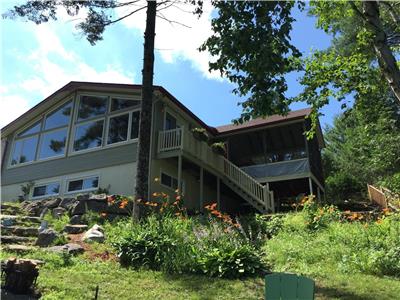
(200, 1, 302, 122)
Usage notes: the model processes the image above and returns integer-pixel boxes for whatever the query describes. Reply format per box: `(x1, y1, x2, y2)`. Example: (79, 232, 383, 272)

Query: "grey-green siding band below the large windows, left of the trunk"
(1, 142, 137, 185)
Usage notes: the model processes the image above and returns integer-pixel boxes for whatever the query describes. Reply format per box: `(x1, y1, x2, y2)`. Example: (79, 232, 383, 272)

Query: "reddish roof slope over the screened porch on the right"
(216, 108, 311, 134)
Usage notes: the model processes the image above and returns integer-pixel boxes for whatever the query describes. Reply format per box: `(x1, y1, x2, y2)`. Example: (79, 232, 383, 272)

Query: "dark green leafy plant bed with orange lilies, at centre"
(111, 215, 265, 278)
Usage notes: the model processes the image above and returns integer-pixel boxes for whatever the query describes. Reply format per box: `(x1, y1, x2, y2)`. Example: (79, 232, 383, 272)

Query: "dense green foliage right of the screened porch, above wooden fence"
(323, 95, 400, 202)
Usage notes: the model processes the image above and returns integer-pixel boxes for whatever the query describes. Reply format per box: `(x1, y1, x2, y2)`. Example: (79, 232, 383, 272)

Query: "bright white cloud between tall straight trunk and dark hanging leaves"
(117, 1, 222, 80)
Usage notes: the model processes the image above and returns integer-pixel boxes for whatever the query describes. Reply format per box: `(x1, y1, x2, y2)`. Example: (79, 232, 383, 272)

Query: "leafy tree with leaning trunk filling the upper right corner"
(201, 0, 400, 134)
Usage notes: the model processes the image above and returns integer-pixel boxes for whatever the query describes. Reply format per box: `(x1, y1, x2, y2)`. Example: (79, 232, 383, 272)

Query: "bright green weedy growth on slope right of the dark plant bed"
(264, 213, 400, 276)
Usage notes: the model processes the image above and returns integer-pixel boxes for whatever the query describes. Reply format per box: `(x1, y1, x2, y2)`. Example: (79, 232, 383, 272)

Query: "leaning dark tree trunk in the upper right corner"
(363, 0, 400, 101)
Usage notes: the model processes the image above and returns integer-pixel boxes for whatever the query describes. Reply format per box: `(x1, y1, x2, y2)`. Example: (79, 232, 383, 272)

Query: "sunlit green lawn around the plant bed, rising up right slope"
(1, 198, 400, 300)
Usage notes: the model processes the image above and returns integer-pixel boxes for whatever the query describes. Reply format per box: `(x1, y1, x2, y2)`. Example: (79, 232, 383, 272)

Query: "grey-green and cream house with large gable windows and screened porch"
(1, 82, 324, 213)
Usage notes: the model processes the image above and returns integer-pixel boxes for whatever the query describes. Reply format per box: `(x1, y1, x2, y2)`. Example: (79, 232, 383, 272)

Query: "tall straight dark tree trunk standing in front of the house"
(132, 1, 157, 218)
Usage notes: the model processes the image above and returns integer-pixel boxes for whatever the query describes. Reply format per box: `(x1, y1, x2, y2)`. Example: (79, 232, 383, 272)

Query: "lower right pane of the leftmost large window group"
(39, 129, 67, 158)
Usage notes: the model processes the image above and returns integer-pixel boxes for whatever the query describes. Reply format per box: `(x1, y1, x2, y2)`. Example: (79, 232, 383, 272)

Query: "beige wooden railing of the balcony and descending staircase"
(158, 127, 274, 211)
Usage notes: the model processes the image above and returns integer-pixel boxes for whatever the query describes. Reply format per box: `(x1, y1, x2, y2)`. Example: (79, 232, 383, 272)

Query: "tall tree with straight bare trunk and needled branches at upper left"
(3, 0, 202, 216)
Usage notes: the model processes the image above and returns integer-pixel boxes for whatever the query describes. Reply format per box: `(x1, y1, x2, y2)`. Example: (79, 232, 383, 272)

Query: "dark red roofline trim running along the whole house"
(1, 81, 321, 145)
